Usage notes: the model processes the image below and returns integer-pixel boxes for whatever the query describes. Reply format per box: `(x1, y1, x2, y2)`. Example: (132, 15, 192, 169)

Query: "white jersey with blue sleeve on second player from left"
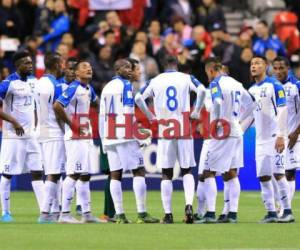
(37, 75, 64, 141)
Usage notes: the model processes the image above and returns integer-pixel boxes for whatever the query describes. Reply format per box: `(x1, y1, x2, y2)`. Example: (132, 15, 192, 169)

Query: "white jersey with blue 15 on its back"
(209, 75, 251, 137)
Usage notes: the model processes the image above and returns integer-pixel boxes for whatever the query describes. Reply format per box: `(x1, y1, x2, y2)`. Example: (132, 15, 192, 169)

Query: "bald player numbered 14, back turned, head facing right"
(99, 59, 159, 223)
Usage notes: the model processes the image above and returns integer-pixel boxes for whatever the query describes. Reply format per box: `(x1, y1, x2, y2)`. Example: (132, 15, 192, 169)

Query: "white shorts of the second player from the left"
(40, 140, 66, 175)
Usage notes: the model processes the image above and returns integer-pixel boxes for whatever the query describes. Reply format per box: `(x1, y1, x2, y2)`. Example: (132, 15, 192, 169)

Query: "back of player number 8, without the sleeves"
(150, 71, 192, 121)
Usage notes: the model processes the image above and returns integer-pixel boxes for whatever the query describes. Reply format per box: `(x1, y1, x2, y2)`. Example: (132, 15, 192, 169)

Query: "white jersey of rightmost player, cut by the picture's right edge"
(283, 77, 300, 137)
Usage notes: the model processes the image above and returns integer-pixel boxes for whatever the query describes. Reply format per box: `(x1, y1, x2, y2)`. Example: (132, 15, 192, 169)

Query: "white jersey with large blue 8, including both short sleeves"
(141, 70, 205, 136)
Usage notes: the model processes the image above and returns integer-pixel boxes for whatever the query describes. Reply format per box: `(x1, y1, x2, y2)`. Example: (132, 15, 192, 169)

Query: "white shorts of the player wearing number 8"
(156, 139, 196, 168)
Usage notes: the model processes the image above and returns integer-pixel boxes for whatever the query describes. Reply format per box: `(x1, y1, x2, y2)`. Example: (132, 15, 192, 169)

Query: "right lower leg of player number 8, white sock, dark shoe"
(181, 168, 195, 224)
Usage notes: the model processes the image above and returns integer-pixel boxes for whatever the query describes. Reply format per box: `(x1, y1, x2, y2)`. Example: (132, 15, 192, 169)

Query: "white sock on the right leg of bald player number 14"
(133, 176, 147, 213)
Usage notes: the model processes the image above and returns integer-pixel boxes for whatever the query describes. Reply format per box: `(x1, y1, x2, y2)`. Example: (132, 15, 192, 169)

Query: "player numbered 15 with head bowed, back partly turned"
(198, 58, 251, 223)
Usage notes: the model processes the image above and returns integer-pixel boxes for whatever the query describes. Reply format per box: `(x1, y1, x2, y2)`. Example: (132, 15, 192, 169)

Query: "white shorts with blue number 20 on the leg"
(255, 141, 286, 177)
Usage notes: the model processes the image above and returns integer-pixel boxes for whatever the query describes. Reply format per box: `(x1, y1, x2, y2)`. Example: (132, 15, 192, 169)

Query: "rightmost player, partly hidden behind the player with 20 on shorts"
(273, 57, 300, 203)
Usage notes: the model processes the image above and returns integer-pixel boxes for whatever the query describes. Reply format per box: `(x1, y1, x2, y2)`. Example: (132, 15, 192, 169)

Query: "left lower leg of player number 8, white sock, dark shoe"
(160, 168, 173, 224)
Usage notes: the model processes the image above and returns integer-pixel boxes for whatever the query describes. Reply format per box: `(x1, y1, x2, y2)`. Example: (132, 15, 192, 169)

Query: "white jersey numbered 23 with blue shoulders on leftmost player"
(0, 73, 38, 138)
